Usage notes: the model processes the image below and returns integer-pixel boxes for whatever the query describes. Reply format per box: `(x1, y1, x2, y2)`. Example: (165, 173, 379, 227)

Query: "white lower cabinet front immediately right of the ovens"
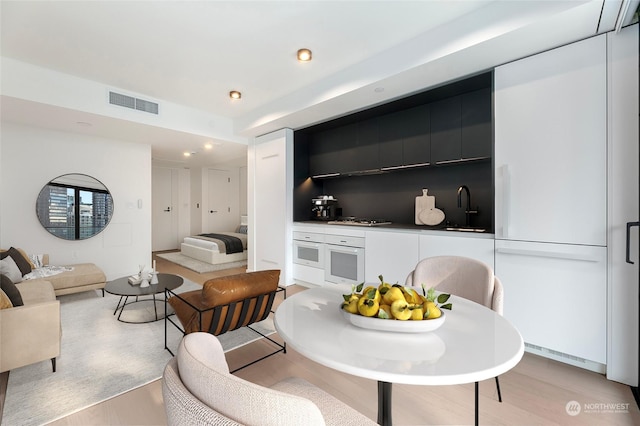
(365, 231, 419, 284)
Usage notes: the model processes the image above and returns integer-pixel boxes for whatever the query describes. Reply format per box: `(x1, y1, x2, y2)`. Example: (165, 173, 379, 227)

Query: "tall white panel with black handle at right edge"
(607, 24, 640, 386)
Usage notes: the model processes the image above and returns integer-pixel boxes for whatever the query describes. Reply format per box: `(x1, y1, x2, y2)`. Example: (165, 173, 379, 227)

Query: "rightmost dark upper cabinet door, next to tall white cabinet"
(461, 88, 493, 159)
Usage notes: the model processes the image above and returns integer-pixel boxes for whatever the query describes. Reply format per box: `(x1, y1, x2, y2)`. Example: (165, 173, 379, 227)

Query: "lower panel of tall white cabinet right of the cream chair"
(495, 240, 607, 368)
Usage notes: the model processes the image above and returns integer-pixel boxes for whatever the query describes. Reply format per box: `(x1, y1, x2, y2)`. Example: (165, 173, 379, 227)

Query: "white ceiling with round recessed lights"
(0, 0, 635, 165)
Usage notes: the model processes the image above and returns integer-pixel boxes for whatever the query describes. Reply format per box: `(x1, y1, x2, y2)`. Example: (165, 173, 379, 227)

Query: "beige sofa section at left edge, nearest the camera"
(0, 280, 62, 373)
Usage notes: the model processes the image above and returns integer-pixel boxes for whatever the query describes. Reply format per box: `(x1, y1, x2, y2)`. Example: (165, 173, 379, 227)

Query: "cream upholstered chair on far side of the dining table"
(405, 256, 504, 425)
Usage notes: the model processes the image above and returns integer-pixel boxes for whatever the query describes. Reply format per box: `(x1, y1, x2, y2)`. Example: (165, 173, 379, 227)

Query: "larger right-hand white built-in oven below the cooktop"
(324, 235, 364, 284)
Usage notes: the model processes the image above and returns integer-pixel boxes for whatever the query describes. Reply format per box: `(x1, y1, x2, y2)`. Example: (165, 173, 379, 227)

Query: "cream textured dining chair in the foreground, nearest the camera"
(162, 332, 376, 426)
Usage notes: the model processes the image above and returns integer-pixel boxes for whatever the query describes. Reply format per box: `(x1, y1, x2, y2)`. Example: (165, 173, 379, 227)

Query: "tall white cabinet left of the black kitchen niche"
(247, 129, 293, 285)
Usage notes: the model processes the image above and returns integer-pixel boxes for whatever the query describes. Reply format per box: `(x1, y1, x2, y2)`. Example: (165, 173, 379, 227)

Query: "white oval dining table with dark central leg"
(274, 286, 524, 426)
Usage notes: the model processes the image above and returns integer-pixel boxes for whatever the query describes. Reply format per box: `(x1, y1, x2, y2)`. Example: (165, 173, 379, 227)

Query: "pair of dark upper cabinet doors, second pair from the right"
(378, 105, 431, 168)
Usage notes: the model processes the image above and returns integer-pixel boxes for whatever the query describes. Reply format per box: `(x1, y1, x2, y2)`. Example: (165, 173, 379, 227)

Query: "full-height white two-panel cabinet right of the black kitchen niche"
(494, 35, 607, 371)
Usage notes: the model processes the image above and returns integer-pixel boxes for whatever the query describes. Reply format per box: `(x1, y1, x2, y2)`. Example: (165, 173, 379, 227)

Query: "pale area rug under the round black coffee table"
(2, 280, 275, 425)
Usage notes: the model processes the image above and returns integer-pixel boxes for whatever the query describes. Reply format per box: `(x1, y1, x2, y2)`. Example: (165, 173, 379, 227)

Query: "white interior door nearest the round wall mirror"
(151, 167, 178, 251)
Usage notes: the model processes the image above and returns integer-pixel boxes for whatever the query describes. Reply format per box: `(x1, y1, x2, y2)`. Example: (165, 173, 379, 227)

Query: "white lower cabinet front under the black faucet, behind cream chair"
(419, 233, 495, 269)
